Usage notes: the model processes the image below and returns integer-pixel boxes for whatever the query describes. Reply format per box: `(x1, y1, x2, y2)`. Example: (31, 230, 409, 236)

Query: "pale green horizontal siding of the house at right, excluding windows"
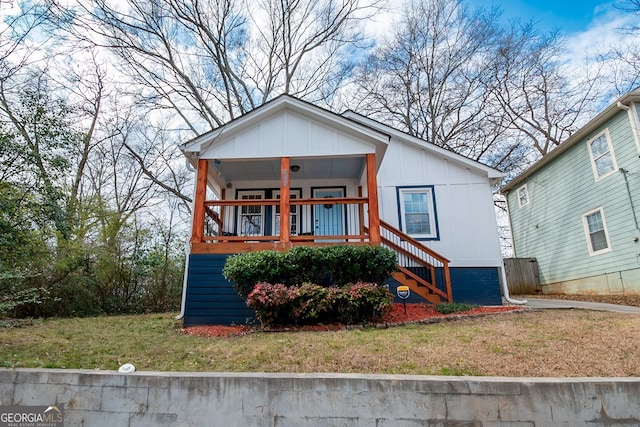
(508, 110, 640, 290)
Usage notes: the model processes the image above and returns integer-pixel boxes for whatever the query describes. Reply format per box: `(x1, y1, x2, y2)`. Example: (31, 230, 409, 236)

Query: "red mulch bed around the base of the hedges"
(183, 304, 522, 337)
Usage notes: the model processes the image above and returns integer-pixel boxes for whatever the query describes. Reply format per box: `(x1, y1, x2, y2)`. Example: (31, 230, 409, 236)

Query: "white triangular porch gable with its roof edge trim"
(180, 95, 390, 166)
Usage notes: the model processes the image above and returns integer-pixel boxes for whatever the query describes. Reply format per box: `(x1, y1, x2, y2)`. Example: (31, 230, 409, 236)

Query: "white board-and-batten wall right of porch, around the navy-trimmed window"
(378, 136, 502, 267)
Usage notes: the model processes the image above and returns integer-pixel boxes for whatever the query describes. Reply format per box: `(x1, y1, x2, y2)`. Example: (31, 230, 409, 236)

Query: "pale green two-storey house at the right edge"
(502, 89, 640, 294)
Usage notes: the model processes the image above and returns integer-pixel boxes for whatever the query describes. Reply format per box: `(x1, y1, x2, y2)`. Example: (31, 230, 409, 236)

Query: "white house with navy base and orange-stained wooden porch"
(181, 95, 503, 326)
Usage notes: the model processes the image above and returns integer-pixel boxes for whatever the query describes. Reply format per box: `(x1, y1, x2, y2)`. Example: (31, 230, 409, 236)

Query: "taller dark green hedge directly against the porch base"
(222, 245, 397, 298)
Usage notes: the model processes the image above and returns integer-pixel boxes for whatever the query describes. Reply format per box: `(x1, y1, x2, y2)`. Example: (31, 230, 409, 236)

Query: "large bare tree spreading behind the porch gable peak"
(58, 0, 378, 134)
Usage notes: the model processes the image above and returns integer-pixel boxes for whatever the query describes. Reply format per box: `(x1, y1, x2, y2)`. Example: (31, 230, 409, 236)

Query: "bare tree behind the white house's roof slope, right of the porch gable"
(356, 0, 499, 162)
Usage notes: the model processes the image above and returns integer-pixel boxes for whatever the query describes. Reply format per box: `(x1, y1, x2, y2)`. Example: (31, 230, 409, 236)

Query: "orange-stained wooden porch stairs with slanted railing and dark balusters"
(380, 221, 453, 303)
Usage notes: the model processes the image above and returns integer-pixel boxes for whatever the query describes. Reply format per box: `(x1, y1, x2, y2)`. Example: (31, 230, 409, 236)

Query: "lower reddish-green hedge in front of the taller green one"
(247, 282, 393, 326)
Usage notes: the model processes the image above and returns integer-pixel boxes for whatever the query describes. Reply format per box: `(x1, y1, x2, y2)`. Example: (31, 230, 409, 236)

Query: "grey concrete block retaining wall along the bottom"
(0, 369, 640, 427)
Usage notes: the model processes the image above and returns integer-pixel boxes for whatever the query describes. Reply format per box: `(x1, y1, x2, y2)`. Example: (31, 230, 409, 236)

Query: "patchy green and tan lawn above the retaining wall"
(0, 310, 640, 377)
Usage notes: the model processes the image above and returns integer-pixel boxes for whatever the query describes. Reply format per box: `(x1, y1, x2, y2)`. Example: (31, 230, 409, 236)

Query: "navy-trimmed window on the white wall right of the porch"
(398, 186, 438, 239)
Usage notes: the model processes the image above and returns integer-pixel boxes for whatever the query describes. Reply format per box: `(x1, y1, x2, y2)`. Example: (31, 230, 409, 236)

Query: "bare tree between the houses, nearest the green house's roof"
(487, 22, 602, 159)
